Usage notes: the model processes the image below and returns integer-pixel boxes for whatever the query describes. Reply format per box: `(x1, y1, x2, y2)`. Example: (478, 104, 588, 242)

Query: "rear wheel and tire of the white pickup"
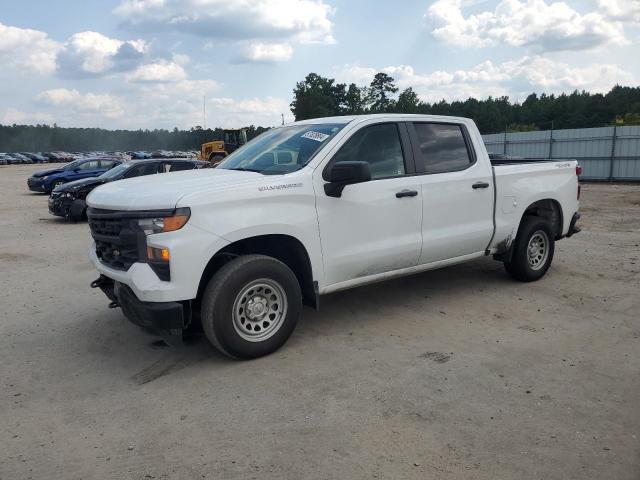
(504, 216, 555, 282)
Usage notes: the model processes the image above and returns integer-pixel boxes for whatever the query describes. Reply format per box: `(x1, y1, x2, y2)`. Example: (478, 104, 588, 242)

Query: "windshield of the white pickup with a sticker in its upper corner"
(218, 123, 346, 175)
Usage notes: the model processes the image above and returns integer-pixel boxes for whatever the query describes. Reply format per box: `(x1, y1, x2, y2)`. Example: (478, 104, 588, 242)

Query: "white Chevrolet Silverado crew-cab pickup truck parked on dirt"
(87, 115, 580, 358)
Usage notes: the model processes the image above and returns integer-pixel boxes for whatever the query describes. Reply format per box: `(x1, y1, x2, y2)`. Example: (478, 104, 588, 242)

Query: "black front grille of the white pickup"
(88, 210, 141, 271)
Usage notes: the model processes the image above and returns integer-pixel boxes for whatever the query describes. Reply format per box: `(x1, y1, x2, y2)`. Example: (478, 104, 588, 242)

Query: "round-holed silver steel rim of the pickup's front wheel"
(232, 278, 287, 342)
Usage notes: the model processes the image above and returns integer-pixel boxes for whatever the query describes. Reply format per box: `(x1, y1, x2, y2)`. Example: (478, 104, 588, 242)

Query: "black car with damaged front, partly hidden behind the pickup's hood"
(49, 158, 211, 221)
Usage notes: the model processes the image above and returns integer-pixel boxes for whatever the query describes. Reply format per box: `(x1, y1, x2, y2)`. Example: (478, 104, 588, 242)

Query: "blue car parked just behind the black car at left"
(27, 157, 124, 193)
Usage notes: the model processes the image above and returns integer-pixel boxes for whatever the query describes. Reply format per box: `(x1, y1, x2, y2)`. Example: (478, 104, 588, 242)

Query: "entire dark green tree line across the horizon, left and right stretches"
(0, 72, 640, 152)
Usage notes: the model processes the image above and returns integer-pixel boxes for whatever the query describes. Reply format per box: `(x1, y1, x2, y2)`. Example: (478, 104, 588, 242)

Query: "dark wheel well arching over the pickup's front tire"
(198, 235, 317, 307)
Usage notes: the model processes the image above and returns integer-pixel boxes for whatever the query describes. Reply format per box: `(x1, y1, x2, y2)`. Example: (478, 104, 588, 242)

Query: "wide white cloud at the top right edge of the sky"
(426, 0, 636, 50)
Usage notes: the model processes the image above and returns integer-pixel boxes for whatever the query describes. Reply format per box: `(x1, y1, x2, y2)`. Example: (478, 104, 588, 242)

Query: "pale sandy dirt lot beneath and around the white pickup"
(0, 166, 640, 480)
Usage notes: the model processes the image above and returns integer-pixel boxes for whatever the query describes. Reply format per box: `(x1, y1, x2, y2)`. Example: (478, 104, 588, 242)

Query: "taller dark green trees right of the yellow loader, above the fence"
(291, 72, 640, 134)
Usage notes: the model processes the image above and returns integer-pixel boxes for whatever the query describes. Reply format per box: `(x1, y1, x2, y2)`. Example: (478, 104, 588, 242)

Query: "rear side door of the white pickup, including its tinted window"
(409, 122, 494, 264)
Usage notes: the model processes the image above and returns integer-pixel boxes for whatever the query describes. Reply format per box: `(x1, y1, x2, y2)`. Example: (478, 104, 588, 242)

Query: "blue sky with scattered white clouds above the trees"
(0, 0, 640, 129)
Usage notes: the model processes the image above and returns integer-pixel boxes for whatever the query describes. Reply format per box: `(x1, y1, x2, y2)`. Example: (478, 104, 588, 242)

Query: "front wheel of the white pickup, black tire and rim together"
(200, 255, 302, 359)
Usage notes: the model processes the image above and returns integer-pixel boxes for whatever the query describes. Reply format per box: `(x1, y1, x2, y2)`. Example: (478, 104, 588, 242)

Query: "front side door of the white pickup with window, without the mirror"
(314, 122, 422, 285)
